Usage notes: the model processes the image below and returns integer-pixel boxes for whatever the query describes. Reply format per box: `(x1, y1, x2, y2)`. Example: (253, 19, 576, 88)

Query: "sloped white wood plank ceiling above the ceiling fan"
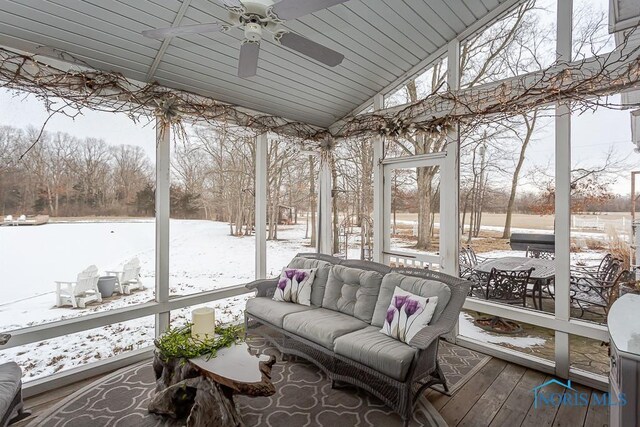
(0, 0, 512, 127)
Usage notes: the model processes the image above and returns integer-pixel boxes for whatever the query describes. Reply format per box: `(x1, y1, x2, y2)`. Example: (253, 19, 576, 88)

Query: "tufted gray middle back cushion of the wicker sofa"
(322, 265, 382, 323)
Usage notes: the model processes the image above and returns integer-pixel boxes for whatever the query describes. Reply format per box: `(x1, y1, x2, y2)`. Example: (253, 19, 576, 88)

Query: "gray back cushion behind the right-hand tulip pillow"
(371, 273, 451, 328)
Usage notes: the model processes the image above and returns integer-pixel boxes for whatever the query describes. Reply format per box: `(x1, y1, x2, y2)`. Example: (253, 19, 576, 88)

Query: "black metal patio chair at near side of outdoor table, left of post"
(485, 268, 534, 307)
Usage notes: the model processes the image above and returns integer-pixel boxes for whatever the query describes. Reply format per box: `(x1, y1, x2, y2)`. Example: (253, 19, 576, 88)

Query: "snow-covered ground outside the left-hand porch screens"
(0, 219, 312, 380)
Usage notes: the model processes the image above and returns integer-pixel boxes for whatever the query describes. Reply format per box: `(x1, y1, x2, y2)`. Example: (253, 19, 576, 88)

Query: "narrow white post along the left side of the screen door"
(372, 94, 384, 263)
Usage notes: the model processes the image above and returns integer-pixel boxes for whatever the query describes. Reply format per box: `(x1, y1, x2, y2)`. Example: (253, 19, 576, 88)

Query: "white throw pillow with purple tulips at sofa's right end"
(380, 286, 438, 344)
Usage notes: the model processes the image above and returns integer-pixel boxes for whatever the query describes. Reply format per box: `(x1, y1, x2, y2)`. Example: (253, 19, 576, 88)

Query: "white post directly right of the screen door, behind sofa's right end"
(440, 39, 460, 277)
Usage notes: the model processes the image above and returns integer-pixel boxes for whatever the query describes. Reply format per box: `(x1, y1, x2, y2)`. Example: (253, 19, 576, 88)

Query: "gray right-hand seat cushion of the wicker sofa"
(334, 326, 417, 381)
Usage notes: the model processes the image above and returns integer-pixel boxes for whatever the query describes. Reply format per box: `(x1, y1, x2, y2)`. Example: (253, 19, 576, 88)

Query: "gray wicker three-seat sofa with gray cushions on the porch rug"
(245, 254, 470, 423)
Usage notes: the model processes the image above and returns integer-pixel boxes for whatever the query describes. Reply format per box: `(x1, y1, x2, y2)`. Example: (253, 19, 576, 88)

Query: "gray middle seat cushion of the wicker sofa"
(282, 308, 369, 350)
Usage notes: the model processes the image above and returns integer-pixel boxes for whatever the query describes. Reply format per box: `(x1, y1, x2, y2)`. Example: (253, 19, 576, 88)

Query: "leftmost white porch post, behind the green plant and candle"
(155, 117, 171, 337)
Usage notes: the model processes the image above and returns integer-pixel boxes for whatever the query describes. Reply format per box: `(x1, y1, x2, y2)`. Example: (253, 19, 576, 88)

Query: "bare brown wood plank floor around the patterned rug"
(14, 358, 609, 427)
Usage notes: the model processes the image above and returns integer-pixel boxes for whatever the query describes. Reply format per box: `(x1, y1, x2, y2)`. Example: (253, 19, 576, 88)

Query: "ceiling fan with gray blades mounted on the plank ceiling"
(142, 0, 348, 78)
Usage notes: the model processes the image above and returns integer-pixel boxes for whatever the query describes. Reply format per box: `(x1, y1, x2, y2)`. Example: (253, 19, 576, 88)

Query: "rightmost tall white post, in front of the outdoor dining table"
(555, 0, 573, 378)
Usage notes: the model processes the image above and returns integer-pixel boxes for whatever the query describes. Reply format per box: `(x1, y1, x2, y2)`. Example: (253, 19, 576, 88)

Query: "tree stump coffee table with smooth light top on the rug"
(149, 343, 276, 427)
